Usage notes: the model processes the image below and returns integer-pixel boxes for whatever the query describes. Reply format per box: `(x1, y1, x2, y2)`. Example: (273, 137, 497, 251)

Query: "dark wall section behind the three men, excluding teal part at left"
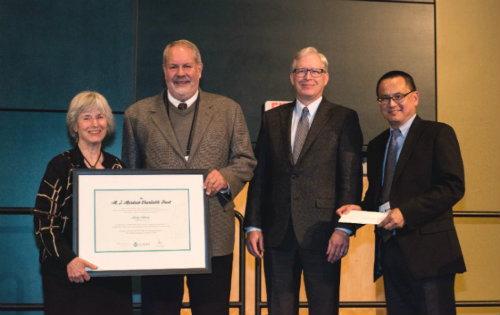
(137, 0, 435, 143)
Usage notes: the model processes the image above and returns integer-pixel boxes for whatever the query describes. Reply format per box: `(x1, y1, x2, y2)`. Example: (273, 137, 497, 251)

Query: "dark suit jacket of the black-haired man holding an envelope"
(363, 116, 465, 278)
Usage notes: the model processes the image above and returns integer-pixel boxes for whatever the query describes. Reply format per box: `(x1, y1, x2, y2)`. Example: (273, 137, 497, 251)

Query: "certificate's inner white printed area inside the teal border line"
(94, 188, 191, 253)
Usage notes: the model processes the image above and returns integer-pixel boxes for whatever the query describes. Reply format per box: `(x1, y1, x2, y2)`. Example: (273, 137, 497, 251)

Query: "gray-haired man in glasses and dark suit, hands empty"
(245, 47, 362, 315)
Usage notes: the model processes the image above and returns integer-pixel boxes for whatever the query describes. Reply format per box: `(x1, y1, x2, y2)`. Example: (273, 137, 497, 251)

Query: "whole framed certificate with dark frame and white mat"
(73, 169, 211, 276)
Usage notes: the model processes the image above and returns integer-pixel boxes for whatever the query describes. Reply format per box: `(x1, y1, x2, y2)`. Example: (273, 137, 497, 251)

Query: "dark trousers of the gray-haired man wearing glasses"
(264, 224, 340, 315)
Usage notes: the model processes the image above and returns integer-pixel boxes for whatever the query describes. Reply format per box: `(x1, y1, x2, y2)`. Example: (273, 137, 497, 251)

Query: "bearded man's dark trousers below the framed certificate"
(142, 254, 233, 315)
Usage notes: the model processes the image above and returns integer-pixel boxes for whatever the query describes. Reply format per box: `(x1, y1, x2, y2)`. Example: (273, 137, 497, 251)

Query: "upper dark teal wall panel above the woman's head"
(0, 0, 135, 110)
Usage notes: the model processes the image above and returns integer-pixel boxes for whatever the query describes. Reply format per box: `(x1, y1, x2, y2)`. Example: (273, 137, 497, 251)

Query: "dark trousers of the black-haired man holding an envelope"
(382, 238, 456, 315)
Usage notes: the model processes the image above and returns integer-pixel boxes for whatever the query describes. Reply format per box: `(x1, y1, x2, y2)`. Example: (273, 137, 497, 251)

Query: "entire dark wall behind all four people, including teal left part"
(0, 0, 436, 310)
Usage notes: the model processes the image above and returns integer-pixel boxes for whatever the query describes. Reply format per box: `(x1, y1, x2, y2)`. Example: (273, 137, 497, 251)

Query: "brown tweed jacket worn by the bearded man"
(122, 91, 256, 256)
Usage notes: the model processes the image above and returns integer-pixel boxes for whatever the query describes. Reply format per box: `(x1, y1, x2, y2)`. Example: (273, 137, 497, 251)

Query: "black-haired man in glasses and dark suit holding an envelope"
(337, 71, 465, 315)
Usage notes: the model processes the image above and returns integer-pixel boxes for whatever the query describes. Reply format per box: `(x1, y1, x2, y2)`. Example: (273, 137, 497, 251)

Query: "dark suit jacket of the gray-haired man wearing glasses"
(245, 98, 363, 250)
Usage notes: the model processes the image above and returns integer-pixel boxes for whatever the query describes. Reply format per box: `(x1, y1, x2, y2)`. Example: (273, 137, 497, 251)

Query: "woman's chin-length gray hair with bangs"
(66, 91, 115, 143)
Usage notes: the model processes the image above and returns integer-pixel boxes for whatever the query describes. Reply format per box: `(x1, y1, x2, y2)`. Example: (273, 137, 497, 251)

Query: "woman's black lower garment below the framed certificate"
(41, 265, 132, 315)
